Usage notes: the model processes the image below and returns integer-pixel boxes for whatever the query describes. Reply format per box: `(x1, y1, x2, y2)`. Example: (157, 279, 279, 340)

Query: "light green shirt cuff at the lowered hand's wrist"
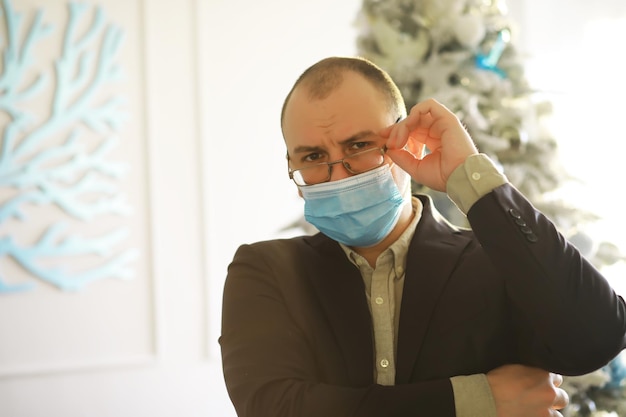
(450, 374, 496, 417)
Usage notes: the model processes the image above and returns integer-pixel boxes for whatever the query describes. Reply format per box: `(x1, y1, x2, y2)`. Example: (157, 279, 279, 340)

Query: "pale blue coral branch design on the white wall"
(0, 0, 137, 294)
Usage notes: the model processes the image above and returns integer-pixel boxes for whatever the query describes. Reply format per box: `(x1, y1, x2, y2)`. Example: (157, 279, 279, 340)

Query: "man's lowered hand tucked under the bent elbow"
(487, 365, 569, 417)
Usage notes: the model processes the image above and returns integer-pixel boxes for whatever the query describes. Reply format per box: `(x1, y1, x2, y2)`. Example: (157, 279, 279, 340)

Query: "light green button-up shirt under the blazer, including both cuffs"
(341, 154, 507, 417)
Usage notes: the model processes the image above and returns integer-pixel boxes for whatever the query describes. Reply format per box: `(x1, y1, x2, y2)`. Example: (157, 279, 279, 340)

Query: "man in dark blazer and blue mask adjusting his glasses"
(220, 58, 626, 417)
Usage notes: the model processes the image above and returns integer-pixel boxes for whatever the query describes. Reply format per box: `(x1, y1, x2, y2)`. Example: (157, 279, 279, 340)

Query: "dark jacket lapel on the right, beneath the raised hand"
(396, 198, 470, 384)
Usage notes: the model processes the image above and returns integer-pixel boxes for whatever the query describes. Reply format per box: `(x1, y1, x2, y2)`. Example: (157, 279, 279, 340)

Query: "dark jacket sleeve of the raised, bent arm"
(468, 183, 626, 375)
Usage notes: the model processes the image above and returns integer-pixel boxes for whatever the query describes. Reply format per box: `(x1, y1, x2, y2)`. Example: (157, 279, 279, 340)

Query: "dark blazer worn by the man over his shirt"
(220, 184, 626, 417)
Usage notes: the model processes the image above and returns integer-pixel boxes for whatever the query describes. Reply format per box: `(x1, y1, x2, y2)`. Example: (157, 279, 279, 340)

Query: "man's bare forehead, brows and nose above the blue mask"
(283, 72, 395, 181)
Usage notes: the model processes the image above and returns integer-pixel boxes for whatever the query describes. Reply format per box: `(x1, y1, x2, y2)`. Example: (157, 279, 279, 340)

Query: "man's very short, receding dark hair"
(280, 57, 406, 128)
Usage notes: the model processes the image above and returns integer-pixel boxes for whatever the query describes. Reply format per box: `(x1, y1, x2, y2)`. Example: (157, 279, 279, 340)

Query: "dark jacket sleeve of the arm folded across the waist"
(219, 244, 455, 417)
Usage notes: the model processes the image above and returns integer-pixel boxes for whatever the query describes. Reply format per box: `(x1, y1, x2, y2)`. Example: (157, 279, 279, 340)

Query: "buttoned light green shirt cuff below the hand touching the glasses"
(446, 153, 508, 214)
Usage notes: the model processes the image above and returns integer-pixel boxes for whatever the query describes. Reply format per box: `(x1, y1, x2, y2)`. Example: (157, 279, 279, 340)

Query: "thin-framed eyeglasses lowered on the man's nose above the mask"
(289, 147, 387, 186)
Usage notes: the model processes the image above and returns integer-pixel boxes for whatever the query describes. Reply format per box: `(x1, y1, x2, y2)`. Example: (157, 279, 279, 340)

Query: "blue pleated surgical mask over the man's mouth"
(298, 164, 404, 247)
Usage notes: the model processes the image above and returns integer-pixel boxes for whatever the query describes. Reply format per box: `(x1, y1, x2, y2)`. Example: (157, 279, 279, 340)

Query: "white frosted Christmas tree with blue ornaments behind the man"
(357, 0, 626, 417)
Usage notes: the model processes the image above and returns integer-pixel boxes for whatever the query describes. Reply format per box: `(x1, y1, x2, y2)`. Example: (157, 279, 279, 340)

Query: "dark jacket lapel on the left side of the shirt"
(309, 233, 374, 386)
